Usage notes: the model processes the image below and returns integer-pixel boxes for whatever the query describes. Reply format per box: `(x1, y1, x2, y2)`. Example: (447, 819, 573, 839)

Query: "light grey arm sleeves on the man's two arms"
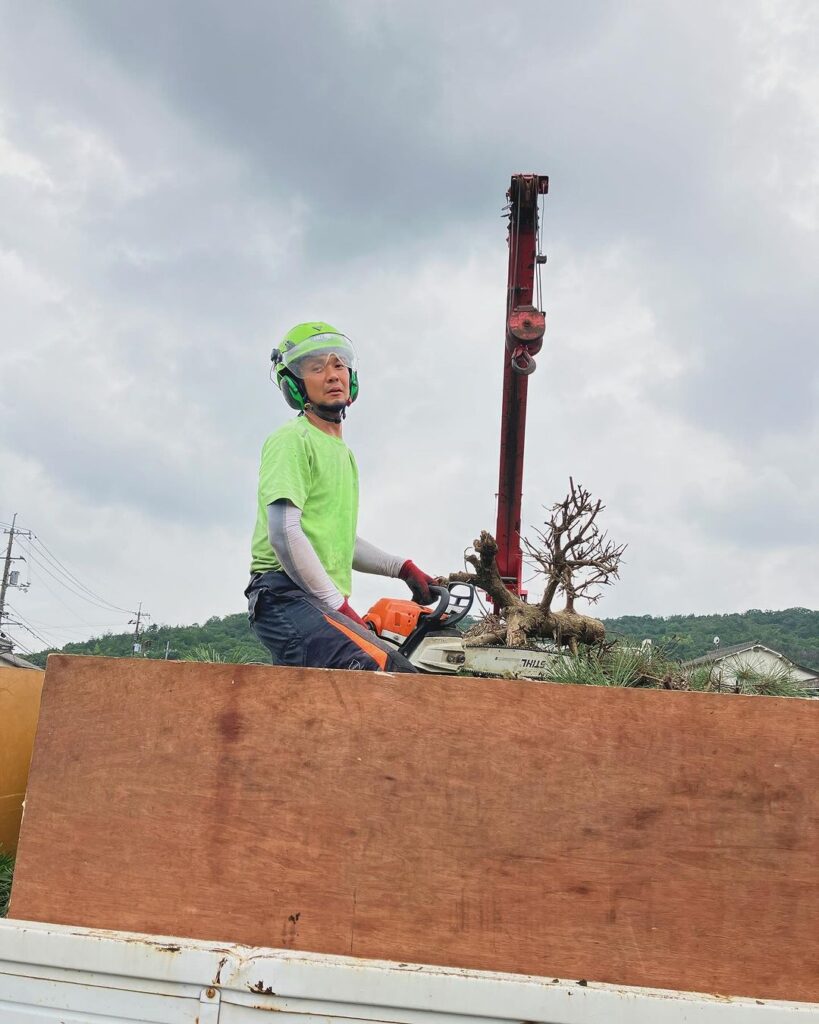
(267, 499, 406, 608)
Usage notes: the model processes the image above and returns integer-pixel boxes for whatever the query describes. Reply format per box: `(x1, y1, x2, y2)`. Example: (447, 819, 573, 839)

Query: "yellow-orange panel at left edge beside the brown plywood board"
(0, 668, 45, 853)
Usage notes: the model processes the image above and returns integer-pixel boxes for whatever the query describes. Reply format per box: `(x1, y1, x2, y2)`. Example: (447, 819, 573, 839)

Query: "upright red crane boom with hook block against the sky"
(494, 174, 549, 598)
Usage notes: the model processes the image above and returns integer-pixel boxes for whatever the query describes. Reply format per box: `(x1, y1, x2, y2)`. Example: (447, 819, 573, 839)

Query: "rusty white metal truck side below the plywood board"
(0, 921, 819, 1024)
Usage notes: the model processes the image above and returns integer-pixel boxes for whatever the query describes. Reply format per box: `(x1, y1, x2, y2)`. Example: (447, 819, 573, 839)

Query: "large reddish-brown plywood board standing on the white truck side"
(11, 655, 819, 1000)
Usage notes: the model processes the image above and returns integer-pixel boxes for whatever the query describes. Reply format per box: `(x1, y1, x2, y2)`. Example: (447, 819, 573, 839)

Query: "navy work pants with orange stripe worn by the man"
(245, 571, 418, 672)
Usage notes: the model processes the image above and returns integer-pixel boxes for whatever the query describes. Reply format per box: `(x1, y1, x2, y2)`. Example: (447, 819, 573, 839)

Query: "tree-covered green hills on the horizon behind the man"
(29, 608, 819, 671)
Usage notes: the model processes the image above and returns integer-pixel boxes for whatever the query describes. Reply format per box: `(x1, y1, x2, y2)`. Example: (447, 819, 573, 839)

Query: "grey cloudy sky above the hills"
(0, 0, 819, 649)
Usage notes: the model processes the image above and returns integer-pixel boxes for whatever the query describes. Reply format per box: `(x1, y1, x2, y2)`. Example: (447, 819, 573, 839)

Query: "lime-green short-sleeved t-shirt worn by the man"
(251, 416, 358, 597)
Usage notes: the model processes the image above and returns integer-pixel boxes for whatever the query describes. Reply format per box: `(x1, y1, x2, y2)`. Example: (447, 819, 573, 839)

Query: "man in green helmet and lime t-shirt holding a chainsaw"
(245, 322, 433, 672)
